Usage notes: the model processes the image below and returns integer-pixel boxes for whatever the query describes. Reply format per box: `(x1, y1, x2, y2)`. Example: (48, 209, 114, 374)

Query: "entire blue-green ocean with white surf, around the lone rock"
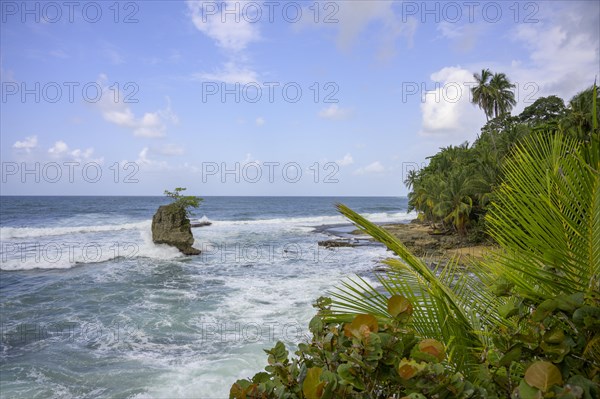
(0, 196, 414, 399)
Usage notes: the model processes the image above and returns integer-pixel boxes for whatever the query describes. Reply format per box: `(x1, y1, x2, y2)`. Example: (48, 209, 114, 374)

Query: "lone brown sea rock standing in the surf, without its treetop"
(152, 204, 200, 255)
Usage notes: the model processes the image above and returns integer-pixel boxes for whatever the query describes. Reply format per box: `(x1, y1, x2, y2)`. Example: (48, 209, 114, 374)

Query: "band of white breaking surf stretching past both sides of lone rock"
(0, 212, 415, 270)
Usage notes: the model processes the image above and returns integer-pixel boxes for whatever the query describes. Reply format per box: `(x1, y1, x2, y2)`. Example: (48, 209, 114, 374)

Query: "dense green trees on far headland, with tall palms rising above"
(404, 79, 597, 241)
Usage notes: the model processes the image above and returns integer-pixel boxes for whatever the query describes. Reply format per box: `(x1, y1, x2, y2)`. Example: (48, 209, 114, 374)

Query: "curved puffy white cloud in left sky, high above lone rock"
(96, 74, 178, 137)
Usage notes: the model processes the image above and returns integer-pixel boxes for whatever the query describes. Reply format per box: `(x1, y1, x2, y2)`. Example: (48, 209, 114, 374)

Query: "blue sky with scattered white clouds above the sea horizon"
(0, 0, 600, 196)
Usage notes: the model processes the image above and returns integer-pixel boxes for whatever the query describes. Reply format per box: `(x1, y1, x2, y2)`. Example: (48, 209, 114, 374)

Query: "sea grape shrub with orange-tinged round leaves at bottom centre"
(230, 296, 486, 399)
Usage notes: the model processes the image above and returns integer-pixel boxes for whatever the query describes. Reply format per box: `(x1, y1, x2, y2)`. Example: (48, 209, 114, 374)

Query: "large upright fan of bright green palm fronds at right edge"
(487, 134, 600, 299)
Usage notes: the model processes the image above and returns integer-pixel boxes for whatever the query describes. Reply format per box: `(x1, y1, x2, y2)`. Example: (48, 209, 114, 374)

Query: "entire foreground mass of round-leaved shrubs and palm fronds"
(230, 83, 600, 399)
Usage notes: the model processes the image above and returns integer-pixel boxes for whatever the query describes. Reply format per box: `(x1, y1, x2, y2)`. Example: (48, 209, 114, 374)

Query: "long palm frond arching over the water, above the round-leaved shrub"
(330, 204, 499, 376)
